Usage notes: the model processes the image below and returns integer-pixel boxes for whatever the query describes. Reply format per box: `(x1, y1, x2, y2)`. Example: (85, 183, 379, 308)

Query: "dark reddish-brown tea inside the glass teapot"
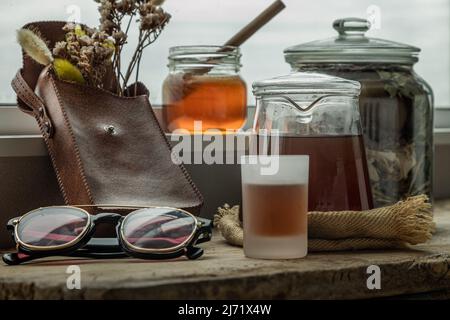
(262, 135, 373, 211)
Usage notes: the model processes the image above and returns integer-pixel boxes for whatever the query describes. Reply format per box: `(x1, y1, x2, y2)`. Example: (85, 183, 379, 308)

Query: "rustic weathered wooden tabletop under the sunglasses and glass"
(0, 200, 450, 299)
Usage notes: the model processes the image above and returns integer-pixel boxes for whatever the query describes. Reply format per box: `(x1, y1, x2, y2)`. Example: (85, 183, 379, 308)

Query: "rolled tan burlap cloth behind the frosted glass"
(214, 195, 435, 252)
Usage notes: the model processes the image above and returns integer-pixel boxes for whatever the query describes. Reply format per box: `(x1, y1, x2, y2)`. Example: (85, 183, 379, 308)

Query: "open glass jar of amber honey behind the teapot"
(162, 46, 247, 132)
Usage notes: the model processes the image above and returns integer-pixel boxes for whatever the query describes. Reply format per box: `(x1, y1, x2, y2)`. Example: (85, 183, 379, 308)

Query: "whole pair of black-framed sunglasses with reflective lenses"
(3, 205, 212, 265)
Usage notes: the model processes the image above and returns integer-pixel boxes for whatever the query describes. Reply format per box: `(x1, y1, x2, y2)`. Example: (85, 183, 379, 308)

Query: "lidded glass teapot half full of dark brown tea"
(253, 72, 373, 211)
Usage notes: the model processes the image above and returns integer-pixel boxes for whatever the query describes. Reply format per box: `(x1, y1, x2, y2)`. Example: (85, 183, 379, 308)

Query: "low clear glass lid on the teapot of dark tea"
(253, 72, 361, 96)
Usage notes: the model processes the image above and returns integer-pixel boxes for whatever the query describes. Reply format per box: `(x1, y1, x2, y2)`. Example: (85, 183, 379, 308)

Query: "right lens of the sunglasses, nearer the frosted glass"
(122, 208, 196, 249)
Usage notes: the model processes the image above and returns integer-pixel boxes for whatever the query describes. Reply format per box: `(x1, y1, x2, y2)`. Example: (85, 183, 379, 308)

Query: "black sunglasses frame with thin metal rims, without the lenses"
(3, 205, 212, 265)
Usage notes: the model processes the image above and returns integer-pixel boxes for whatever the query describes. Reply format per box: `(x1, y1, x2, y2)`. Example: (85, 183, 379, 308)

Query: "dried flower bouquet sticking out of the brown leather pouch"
(17, 0, 170, 95)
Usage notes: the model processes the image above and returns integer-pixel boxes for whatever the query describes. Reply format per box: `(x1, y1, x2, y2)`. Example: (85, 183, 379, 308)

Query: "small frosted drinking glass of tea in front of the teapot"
(241, 155, 309, 259)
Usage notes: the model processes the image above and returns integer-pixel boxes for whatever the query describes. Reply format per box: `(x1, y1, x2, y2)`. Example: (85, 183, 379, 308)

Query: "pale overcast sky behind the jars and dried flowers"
(0, 0, 450, 106)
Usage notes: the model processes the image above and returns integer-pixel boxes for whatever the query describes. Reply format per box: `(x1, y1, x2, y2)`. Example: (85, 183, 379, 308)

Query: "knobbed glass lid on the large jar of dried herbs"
(284, 18, 420, 67)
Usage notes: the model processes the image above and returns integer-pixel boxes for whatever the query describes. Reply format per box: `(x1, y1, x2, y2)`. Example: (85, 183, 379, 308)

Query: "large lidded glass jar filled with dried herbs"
(284, 18, 433, 207)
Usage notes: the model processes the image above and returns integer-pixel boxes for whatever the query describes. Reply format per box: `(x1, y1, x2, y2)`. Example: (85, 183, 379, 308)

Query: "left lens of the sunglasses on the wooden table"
(17, 207, 89, 248)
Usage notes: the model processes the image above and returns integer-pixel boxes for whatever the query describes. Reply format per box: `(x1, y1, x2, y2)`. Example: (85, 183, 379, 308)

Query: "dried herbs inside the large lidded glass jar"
(361, 69, 432, 206)
